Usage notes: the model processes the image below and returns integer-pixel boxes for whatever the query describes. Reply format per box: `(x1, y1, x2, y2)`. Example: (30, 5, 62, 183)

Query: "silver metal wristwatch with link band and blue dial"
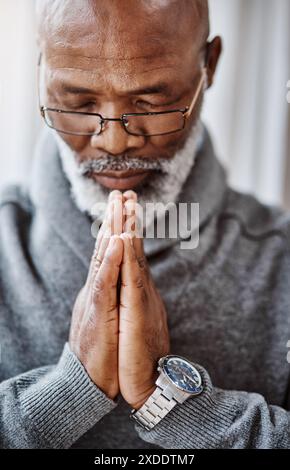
(130, 355, 203, 431)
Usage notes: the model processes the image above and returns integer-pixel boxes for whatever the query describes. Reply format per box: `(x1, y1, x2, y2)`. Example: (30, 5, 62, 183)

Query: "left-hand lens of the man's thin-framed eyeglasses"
(44, 110, 102, 135)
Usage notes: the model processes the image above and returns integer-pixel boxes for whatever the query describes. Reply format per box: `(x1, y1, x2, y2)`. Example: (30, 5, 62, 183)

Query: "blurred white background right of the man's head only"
(204, 0, 290, 207)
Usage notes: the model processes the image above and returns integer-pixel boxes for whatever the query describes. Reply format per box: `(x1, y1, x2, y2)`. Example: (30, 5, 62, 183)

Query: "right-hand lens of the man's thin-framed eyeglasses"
(125, 111, 184, 135)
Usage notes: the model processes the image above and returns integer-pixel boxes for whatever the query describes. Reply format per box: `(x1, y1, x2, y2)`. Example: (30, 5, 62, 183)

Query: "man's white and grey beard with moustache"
(53, 120, 203, 226)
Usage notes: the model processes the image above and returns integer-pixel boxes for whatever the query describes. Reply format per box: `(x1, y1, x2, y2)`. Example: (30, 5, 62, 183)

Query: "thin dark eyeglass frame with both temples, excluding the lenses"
(38, 54, 207, 137)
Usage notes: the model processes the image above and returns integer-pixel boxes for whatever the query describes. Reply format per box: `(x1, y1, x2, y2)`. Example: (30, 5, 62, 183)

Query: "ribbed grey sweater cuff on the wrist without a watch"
(17, 344, 117, 448)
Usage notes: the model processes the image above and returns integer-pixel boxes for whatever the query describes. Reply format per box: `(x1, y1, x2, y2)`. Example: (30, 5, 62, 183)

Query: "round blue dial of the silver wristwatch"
(162, 356, 202, 394)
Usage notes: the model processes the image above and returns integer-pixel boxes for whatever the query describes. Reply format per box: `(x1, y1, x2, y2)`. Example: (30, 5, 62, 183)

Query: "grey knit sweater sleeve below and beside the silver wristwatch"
(136, 364, 290, 449)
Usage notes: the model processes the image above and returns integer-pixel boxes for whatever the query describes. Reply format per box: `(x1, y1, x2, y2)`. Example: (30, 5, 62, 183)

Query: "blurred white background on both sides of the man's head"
(0, 0, 290, 210)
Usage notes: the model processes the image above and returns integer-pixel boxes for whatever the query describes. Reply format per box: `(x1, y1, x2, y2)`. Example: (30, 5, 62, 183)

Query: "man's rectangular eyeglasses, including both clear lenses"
(40, 58, 207, 137)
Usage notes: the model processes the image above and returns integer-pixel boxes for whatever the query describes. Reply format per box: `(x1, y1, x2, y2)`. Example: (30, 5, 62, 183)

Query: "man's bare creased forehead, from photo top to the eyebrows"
(42, 0, 206, 95)
